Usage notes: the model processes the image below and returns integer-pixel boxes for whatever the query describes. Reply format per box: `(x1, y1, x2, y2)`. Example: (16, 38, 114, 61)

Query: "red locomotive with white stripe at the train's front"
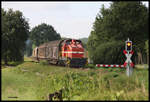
(62, 39, 86, 67)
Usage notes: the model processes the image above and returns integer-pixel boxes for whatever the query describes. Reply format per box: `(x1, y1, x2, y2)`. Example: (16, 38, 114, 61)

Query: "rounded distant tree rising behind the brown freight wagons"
(30, 23, 61, 46)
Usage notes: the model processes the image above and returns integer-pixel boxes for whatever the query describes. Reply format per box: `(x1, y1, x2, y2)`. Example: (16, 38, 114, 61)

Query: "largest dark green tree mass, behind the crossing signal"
(87, 1, 148, 63)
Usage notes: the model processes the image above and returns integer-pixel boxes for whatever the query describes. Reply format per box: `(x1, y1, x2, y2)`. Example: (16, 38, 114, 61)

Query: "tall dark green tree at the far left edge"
(1, 9, 29, 64)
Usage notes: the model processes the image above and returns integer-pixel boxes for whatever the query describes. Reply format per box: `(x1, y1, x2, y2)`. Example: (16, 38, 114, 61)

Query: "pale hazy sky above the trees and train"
(1, 1, 149, 39)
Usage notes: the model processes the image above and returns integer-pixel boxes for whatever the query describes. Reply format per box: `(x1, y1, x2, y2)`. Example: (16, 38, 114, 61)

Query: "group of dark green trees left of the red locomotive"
(1, 8, 61, 65)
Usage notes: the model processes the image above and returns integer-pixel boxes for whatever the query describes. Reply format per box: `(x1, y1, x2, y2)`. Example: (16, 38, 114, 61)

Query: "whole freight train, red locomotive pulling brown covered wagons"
(32, 39, 87, 67)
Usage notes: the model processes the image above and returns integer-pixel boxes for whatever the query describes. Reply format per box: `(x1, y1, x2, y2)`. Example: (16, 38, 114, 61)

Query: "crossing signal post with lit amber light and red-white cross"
(123, 38, 134, 76)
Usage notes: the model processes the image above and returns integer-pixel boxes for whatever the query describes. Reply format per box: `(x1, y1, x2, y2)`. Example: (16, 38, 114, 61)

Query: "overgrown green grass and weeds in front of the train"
(2, 57, 149, 100)
